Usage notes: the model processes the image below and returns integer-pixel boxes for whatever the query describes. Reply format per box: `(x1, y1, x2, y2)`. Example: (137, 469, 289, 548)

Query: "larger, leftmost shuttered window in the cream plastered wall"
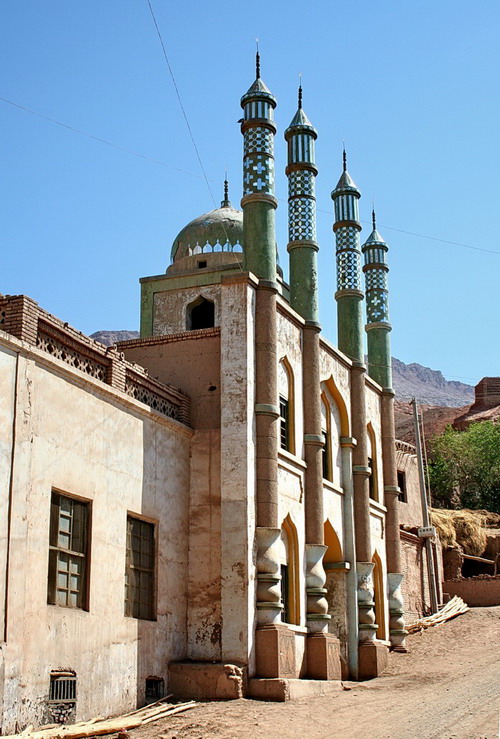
(47, 491, 89, 608)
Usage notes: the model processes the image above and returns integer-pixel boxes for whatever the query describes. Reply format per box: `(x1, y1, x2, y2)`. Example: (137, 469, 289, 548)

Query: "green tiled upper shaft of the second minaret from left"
(285, 85, 318, 323)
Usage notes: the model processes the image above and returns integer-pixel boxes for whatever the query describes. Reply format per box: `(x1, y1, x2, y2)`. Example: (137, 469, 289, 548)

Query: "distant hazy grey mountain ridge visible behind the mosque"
(91, 331, 474, 408)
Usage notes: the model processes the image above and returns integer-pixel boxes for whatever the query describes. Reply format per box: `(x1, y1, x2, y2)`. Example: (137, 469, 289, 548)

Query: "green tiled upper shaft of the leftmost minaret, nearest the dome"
(241, 52, 278, 282)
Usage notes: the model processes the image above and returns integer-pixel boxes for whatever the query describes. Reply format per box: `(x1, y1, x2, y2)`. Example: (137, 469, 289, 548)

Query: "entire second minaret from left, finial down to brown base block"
(285, 85, 340, 668)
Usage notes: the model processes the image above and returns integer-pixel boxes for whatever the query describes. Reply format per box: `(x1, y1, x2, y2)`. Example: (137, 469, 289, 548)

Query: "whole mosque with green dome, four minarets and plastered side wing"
(0, 55, 422, 733)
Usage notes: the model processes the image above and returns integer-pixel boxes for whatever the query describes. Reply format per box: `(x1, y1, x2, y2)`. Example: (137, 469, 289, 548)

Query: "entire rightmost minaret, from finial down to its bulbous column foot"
(363, 210, 407, 652)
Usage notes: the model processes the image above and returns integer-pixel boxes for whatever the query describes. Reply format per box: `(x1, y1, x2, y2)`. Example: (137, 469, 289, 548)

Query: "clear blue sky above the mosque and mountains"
(0, 0, 500, 384)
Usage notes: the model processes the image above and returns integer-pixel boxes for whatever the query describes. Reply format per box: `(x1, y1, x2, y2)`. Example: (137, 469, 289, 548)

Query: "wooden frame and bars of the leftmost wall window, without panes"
(47, 489, 92, 611)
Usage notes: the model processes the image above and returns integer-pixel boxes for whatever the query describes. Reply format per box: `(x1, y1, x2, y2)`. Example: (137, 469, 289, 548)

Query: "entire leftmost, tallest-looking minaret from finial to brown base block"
(241, 51, 287, 677)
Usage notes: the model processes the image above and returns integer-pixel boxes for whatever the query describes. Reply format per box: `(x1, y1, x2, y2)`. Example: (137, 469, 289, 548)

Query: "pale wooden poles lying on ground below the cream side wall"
(2, 696, 196, 739)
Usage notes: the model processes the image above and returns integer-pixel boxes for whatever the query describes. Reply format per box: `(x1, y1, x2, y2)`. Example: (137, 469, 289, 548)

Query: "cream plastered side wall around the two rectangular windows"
(0, 335, 191, 733)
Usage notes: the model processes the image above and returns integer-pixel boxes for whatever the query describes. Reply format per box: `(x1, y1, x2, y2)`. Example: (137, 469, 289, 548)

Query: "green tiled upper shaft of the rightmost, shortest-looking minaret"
(363, 210, 392, 388)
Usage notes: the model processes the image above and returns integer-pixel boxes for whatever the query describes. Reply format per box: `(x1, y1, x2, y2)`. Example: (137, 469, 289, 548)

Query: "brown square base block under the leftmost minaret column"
(255, 624, 299, 678)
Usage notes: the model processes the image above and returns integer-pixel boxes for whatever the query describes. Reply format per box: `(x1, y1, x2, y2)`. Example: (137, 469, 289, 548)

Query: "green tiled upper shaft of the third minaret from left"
(332, 150, 364, 363)
